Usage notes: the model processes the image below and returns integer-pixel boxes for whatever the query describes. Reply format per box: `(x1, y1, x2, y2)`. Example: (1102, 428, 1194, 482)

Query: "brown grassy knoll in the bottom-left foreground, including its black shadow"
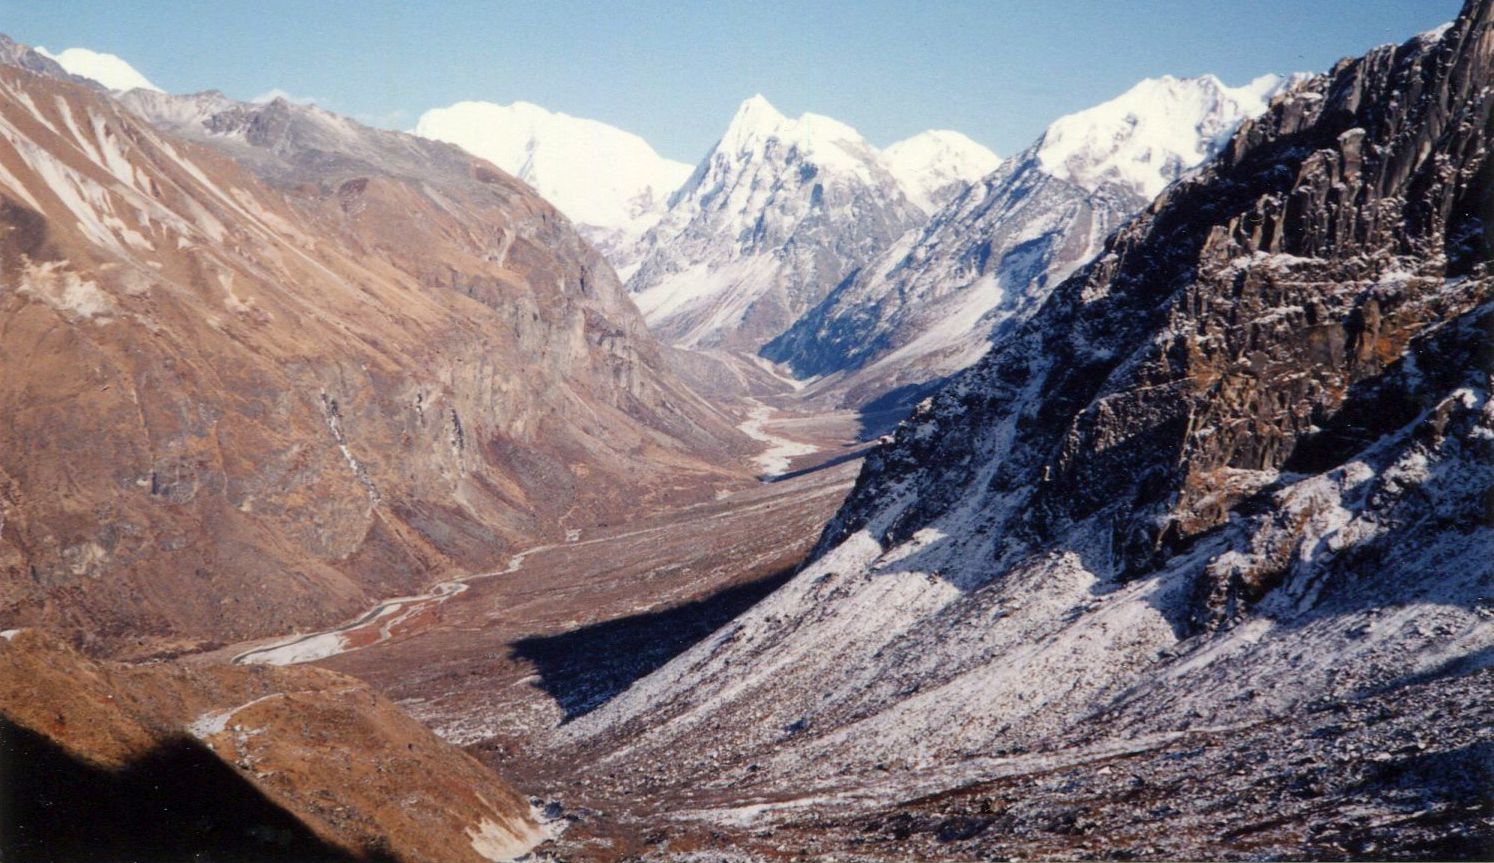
(0, 630, 545, 863)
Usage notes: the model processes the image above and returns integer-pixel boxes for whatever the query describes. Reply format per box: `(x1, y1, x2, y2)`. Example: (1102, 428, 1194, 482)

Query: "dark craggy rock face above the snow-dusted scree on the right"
(826, 4, 1494, 573)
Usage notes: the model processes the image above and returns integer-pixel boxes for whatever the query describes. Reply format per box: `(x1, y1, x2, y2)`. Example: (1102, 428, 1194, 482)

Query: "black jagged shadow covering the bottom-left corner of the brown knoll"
(0, 717, 393, 863)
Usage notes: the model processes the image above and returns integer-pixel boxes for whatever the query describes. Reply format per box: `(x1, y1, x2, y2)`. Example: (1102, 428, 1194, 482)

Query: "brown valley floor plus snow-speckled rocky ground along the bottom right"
(192, 405, 1494, 862)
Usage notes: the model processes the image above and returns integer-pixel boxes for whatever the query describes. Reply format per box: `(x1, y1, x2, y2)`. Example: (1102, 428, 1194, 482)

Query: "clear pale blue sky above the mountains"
(0, 0, 1460, 161)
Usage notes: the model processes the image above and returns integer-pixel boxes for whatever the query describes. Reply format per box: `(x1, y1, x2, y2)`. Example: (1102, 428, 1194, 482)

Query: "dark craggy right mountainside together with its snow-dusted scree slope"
(566, 6, 1494, 856)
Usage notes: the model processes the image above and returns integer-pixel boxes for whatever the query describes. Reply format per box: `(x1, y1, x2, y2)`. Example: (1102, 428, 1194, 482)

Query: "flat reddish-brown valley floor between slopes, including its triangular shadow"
(210, 403, 868, 776)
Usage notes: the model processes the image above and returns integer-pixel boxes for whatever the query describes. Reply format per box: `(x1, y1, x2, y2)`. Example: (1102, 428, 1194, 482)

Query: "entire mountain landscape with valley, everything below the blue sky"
(0, 0, 1494, 863)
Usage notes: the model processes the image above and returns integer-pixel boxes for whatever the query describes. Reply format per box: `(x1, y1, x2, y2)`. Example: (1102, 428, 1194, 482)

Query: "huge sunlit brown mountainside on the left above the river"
(0, 52, 748, 652)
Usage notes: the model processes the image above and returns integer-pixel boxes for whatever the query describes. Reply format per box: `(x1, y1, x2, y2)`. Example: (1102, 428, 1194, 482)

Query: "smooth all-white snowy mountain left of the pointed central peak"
(415, 102, 692, 269)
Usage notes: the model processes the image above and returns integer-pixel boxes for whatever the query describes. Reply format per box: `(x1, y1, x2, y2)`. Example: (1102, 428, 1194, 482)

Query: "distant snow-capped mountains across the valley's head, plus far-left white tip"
(32, 41, 1303, 417)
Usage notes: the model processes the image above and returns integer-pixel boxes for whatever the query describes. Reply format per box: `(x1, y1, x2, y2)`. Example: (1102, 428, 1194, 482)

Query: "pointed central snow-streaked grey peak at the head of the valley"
(627, 96, 925, 349)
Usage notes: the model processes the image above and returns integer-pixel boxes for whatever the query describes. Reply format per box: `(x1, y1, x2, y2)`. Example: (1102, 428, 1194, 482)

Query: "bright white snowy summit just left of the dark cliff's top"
(1037, 75, 1298, 199)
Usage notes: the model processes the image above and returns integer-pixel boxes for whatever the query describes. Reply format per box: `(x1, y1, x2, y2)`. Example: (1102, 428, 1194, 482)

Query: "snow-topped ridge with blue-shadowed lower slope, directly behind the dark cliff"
(763, 75, 1295, 406)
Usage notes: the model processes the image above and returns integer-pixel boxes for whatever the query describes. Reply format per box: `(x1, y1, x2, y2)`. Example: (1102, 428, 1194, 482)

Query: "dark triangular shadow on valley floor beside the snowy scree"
(512, 567, 795, 723)
